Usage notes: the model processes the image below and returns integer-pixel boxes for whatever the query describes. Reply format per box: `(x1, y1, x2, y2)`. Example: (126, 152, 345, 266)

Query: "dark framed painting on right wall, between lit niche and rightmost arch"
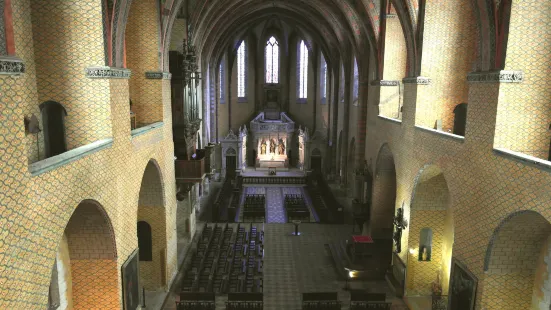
(448, 258, 478, 310)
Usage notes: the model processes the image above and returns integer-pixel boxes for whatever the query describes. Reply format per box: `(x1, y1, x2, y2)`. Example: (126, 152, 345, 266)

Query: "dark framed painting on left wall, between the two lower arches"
(121, 249, 140, 310)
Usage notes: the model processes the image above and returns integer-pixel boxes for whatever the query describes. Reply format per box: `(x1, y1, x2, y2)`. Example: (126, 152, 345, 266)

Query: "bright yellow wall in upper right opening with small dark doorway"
(415, 0, 477, 131)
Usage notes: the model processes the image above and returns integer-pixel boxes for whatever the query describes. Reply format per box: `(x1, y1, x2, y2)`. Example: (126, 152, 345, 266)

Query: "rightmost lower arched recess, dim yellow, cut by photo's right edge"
(481, 211, 551, 309)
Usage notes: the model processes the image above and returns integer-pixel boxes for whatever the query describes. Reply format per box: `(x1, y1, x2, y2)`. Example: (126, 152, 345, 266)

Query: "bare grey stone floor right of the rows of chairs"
(163, 223, 407, 310)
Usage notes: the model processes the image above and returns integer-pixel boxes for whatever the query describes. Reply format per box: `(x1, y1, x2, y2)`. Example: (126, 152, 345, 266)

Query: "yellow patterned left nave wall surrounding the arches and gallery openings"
(0, 0, 177, 309)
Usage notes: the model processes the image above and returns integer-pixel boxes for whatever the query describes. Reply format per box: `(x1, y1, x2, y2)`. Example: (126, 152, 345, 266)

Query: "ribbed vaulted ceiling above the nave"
(185, 0, 418, 73)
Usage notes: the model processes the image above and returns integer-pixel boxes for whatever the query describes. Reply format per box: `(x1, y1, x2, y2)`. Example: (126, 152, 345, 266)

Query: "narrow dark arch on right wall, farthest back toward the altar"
(370, 144, 396, 239)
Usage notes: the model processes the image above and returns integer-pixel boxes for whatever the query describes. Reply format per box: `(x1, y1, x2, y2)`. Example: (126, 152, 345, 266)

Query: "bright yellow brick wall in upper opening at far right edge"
(495, 0, 551, 160)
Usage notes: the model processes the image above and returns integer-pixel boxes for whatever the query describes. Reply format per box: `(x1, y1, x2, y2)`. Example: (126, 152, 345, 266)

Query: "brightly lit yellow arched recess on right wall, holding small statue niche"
(406, 165, 454, 296)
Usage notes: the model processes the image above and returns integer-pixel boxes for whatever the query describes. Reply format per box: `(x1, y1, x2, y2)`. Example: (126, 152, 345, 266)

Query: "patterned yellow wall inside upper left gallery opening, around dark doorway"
(31, 0, 111, 153)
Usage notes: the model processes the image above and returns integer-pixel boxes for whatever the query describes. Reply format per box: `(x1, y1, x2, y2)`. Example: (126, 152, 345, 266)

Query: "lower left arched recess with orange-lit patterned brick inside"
(49, 200, 120, 309)
